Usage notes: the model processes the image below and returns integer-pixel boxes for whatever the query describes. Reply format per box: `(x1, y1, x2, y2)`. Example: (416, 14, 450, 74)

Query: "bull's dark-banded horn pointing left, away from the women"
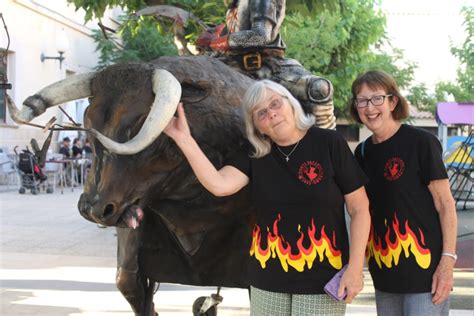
(7, 72, 96, 124)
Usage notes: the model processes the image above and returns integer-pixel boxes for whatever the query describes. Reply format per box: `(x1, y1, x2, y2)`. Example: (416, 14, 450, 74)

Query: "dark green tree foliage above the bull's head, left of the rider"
(67, 0, 226, 65)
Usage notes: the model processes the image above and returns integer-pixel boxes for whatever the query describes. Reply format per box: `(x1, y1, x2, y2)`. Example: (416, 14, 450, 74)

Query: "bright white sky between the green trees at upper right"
(381, 0, 474, 91)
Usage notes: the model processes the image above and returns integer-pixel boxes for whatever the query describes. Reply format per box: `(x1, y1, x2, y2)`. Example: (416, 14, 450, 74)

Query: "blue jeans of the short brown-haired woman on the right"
(375, 290, 449, 316)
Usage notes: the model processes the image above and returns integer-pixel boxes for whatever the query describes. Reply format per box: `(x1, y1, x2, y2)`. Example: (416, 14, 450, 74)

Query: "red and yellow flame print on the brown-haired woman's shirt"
(366, 214, 431, 269)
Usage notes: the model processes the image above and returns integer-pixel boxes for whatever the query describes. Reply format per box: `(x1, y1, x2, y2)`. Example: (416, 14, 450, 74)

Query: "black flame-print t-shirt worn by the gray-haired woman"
(227, 128, 367, 294)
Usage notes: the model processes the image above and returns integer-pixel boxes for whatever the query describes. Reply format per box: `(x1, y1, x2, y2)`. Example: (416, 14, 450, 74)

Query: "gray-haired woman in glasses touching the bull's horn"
(164, 80, 370, 315)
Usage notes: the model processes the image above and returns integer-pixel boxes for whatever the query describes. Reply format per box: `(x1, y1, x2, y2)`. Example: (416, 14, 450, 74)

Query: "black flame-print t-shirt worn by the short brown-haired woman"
(355, 125, 447, 293)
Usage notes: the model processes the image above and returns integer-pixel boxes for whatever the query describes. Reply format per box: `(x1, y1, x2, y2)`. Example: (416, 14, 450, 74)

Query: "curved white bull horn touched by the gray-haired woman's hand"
(91, 69, 181, 155)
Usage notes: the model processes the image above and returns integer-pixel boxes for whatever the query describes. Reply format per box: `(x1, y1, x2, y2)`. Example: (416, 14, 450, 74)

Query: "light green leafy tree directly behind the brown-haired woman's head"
(281, 0, 404, 116)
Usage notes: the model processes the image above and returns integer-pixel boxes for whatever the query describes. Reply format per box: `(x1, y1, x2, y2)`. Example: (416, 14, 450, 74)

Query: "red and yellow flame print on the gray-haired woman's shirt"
(250, 214, 342, 272)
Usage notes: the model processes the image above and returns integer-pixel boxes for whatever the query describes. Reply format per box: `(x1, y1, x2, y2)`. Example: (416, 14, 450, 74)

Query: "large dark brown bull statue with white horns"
(9, 56, 260, 316)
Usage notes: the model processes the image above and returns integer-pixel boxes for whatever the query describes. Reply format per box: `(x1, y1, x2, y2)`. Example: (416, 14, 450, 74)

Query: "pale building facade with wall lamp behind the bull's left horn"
(0, 0, 119, 150)
